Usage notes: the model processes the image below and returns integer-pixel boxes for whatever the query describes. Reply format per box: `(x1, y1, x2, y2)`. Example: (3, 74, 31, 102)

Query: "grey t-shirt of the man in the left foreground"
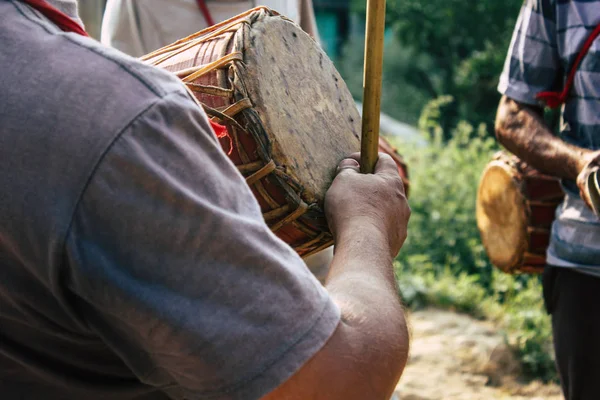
(0, 0, 339, 400)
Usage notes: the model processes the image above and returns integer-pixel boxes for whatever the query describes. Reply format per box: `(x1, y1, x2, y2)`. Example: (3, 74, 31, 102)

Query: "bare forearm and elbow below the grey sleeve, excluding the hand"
(263, 225, 408, 400)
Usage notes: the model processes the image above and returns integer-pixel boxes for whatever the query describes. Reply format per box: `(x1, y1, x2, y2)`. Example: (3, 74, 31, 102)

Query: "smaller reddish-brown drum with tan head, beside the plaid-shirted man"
(477, 152, 564, 273)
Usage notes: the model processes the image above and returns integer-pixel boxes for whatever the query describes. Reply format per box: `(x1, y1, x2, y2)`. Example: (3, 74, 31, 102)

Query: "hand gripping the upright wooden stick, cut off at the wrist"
(325, 153, 410, 257)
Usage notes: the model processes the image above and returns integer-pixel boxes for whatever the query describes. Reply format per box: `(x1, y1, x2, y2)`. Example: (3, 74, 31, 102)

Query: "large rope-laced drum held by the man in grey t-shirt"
(142, 7, 360, 257)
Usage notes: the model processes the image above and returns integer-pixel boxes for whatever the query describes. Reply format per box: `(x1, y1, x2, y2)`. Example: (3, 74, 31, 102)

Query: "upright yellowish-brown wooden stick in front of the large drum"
(360, 0, 385, 173)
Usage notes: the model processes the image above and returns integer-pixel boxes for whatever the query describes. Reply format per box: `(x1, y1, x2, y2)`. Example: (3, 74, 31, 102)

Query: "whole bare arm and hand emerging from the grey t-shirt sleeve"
(263, 154, 410, 400)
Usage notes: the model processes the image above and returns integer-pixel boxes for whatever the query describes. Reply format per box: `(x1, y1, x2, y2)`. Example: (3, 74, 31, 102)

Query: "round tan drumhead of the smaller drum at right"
(477, 161, 528, 271)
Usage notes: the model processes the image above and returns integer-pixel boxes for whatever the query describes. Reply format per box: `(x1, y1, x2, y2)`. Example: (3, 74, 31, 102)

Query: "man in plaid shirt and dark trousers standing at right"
(496, 0, 600, 399)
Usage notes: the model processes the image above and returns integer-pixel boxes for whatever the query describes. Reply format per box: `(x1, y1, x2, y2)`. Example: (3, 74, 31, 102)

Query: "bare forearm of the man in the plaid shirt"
(496, 96, 592, 179)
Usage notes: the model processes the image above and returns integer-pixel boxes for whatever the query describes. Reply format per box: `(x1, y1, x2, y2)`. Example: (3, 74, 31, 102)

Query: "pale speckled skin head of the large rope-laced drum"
(244, 13, 361, 205)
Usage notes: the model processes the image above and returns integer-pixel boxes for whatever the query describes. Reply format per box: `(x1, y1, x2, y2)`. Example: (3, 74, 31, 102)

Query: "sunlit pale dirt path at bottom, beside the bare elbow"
(396, 309, 562, 400)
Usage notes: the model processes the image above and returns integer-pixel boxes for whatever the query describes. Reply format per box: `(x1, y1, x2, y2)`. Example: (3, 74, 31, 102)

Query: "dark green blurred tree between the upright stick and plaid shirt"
(353, 0, 523, 137)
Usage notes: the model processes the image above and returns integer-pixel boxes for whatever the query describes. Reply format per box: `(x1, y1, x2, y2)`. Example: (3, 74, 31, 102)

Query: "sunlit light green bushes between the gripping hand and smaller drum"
(396, 119, 556, 380)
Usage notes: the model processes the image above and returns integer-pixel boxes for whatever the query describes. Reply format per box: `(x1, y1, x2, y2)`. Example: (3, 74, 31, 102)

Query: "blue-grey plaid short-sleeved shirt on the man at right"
(498, 0, 600, 276)
